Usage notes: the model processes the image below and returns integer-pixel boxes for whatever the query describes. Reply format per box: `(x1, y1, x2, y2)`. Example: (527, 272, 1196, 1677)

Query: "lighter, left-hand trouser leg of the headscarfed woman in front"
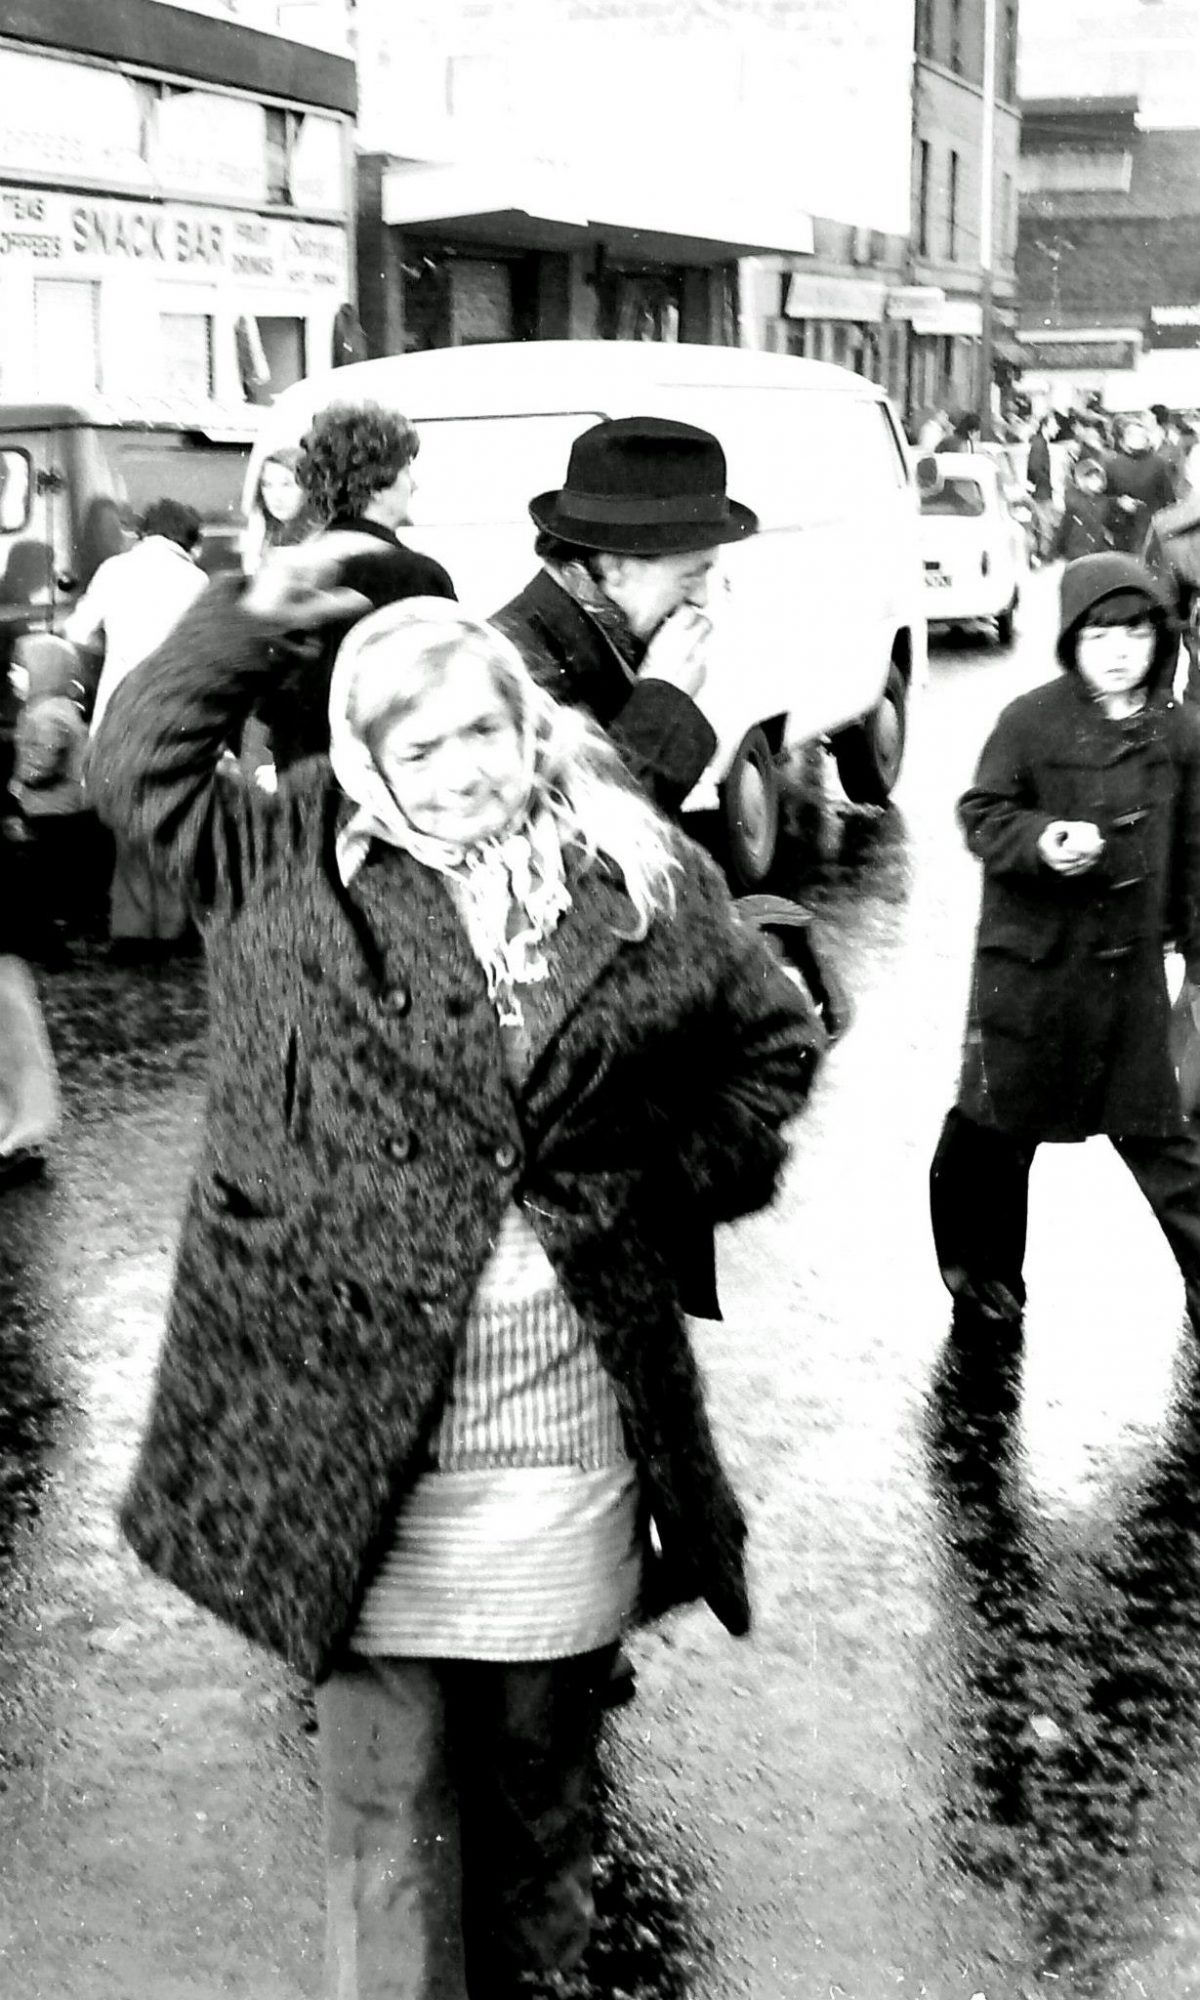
(316, 1654, 466, 2000)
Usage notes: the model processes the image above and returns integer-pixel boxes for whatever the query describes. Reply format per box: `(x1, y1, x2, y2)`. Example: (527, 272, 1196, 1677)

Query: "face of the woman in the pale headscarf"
(374, 652, 528, 846)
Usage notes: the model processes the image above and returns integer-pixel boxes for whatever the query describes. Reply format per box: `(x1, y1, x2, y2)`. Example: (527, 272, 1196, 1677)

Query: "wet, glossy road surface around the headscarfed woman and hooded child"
(0, 576, 1200, 2000)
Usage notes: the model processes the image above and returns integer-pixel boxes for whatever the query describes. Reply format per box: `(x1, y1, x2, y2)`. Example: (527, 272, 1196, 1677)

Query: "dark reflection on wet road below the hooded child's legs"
(926, 1340, 1200, 1994)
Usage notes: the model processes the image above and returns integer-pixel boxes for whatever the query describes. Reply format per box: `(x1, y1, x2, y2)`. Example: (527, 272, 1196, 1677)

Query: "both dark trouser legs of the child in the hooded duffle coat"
(930, 1110, 1200, 1330)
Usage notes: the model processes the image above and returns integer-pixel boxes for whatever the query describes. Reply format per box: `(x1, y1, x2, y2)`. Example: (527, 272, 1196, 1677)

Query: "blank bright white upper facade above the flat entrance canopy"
(358, 0, 912, 234)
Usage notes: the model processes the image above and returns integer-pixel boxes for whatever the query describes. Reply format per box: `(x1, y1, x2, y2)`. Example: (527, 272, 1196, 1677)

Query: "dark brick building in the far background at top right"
(1018, 98, 1200, 408)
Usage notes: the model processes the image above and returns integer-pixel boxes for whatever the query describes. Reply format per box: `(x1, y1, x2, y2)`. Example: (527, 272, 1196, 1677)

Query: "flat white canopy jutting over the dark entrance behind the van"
(382, 160, 812, 264)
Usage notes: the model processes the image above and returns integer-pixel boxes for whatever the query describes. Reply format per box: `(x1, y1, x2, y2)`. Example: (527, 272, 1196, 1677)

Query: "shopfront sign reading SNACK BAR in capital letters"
(0, 188, 348, 298)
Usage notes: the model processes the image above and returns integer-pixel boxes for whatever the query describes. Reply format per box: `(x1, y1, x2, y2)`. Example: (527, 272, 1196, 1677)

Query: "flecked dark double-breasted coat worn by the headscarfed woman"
(92, 584, 822, 1678)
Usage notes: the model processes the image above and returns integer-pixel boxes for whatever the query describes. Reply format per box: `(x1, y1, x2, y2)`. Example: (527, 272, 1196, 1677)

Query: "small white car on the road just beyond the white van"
(920, 452, 1028, 646)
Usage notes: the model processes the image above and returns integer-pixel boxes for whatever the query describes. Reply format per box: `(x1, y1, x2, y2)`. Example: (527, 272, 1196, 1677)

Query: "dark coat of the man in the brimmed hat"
(490, 570, 716, 814)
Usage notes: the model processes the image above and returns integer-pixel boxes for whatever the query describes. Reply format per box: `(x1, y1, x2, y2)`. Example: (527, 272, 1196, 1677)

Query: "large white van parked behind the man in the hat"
(246, 340, 926, 888)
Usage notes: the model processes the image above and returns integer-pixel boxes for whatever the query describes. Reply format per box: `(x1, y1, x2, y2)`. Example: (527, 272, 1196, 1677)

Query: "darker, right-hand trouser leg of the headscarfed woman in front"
(444, 1646, 616, 2000)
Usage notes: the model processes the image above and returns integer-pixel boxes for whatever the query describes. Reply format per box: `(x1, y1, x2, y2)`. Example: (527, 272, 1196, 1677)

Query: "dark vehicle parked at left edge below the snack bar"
(0, 398, 258, 796)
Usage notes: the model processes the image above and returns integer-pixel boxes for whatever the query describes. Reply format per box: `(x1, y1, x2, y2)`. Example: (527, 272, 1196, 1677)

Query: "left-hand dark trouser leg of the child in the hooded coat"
(930, 1108, 1034, 1320)
